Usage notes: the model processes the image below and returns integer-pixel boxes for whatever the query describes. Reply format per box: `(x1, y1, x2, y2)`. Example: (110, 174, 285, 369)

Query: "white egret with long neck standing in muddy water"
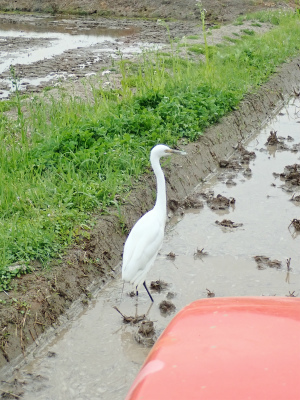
(122, 144, 186, 301)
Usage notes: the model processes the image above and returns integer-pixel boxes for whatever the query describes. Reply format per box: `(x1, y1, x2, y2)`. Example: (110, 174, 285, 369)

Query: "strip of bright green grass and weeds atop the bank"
(0, 12, 300, 290)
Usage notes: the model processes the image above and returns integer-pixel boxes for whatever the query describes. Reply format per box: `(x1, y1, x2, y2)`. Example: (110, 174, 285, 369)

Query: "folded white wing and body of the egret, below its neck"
(122, 210, 165, 285)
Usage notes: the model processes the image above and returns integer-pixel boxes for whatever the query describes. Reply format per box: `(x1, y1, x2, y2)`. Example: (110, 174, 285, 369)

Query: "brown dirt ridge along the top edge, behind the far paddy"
(0, 0, 282, 22)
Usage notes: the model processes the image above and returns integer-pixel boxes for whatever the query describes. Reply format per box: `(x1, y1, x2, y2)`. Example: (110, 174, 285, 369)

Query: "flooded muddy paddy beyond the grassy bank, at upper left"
(0, 15, 153, 99)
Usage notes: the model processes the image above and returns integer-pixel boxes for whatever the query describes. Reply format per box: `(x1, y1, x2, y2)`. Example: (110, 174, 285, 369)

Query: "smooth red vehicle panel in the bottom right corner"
(126, 297, 300, 400)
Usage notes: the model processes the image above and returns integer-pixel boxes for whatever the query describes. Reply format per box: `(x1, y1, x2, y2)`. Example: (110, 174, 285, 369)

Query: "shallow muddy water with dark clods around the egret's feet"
(2, 100, 300, 400)
